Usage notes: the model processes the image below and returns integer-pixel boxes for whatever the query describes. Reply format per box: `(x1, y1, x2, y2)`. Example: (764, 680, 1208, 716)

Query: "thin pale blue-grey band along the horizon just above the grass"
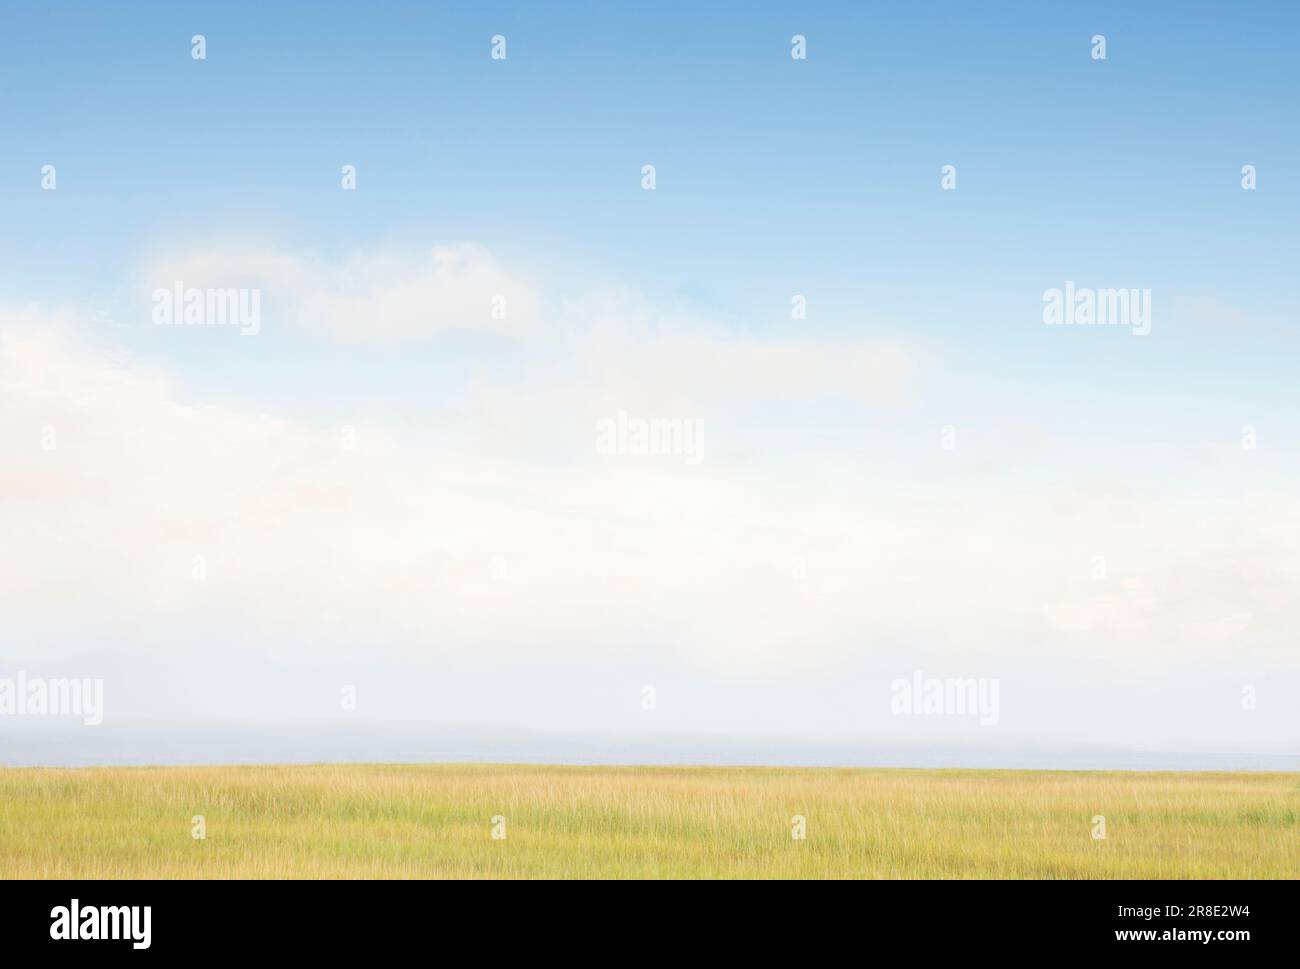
(0, 719, 1300, 771)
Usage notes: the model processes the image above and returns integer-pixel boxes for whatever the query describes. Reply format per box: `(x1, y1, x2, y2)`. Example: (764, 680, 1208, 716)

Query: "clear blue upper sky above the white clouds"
(0, 4, 1300, 418)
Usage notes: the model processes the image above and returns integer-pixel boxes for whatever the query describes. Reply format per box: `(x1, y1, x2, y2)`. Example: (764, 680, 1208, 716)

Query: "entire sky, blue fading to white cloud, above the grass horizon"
(0, 3, 1300, 769)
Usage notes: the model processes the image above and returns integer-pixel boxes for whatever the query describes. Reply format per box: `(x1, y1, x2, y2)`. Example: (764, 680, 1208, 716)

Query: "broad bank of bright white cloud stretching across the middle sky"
(0, 295, 1300, 749)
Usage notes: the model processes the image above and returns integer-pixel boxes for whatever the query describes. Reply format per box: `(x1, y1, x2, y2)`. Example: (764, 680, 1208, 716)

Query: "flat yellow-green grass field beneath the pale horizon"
(0, 765, 1300, 878)
